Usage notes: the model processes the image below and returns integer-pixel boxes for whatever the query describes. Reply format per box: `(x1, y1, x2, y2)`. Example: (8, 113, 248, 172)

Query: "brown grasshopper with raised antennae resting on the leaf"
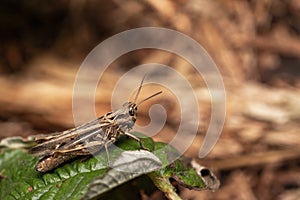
(30, 76, 162, 172)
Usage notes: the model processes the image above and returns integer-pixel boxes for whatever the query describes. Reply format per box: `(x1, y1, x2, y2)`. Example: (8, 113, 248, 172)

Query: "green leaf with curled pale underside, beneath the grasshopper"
(0, 133, 220, 200)
